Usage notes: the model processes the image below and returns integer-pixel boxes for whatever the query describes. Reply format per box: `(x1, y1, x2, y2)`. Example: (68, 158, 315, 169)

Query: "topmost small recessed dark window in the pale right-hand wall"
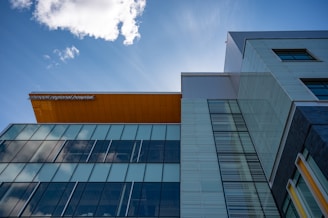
(273, 49, 316, 61)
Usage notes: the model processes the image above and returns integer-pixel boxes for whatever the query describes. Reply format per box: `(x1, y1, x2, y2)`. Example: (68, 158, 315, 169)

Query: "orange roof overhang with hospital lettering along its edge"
(29, 93, 181, 123)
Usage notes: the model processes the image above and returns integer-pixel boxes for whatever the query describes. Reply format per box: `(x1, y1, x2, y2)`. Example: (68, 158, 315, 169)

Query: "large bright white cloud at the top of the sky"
(33, 0, 146, 45)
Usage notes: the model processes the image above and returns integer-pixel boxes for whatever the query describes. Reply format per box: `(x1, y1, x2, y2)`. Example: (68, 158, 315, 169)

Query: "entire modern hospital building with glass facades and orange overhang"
(0, 31, 328, 218)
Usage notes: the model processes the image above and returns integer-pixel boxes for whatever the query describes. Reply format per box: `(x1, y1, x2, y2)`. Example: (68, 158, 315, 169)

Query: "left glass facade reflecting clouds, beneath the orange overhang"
(0, 124, 180, 218)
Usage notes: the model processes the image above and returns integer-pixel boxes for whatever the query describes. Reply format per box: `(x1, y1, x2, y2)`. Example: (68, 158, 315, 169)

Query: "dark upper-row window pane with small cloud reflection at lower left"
(106, 140, 135, 163)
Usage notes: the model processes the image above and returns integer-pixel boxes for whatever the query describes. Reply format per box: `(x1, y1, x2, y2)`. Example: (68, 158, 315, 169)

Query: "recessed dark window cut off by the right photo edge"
(302, 78, 328, 100)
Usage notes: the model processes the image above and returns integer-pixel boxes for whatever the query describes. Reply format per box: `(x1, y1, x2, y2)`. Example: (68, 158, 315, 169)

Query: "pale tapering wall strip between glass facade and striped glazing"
(180, 99, 228, 218)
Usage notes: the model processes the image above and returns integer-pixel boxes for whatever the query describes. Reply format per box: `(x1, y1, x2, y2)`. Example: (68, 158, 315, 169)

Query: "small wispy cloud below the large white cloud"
(43, 45, 80, 69)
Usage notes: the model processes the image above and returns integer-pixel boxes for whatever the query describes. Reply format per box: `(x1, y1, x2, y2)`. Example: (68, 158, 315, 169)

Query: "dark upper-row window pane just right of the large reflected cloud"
(56, 140, 94, 162)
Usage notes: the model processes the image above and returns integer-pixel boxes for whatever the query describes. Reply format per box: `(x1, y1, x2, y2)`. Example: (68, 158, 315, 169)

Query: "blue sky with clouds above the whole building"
(0, 0, 328, 131)
